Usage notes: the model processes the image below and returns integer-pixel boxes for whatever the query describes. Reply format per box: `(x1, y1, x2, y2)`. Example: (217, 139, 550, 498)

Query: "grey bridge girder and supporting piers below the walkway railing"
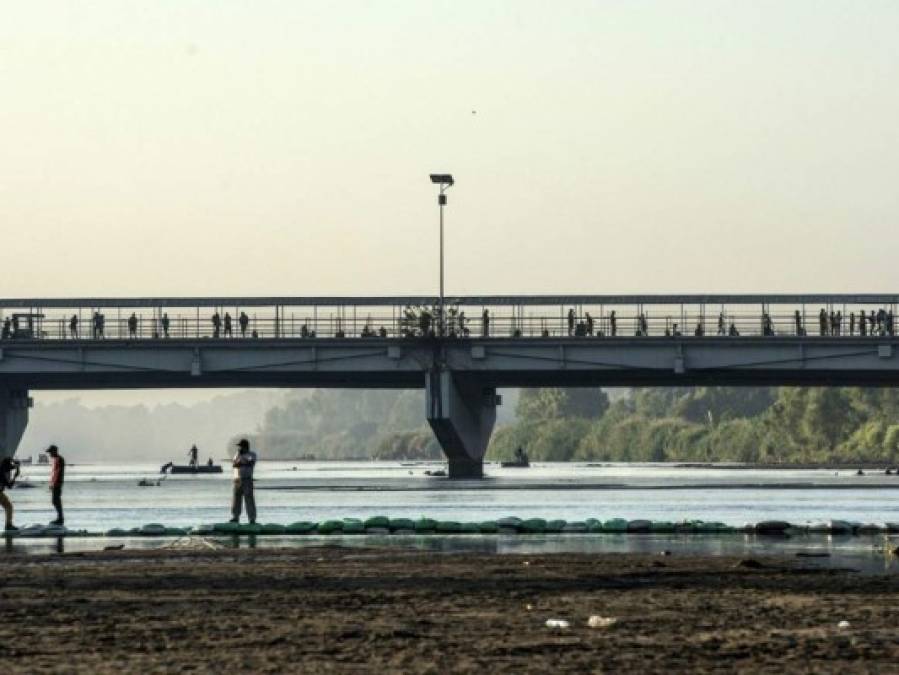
(0, 336, 899, 477)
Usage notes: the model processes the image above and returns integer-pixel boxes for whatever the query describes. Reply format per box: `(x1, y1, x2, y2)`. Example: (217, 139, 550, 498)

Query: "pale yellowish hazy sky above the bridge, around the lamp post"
(0, 0, 899, 296)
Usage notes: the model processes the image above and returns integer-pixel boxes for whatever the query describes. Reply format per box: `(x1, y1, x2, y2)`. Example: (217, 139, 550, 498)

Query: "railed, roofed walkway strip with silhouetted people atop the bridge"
(0, 296, 899, 340)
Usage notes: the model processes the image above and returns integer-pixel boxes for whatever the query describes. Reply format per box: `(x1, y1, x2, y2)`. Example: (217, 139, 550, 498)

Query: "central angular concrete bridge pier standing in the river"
(426, 370, 497, 478)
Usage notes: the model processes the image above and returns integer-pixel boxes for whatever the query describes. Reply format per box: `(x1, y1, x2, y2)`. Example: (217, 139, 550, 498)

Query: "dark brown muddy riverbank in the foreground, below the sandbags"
(0, 542, 899, 673)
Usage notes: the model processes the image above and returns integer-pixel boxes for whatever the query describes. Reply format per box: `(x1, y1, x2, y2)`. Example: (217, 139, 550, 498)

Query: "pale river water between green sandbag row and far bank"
(9, 462, 899, 532)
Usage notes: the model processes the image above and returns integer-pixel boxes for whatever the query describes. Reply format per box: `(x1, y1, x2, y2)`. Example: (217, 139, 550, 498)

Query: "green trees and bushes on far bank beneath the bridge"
(246, 387, 899, 463)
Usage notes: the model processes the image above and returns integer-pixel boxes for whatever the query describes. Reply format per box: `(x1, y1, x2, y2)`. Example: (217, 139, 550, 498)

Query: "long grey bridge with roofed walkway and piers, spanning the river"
(0, 294, 899, 478)
